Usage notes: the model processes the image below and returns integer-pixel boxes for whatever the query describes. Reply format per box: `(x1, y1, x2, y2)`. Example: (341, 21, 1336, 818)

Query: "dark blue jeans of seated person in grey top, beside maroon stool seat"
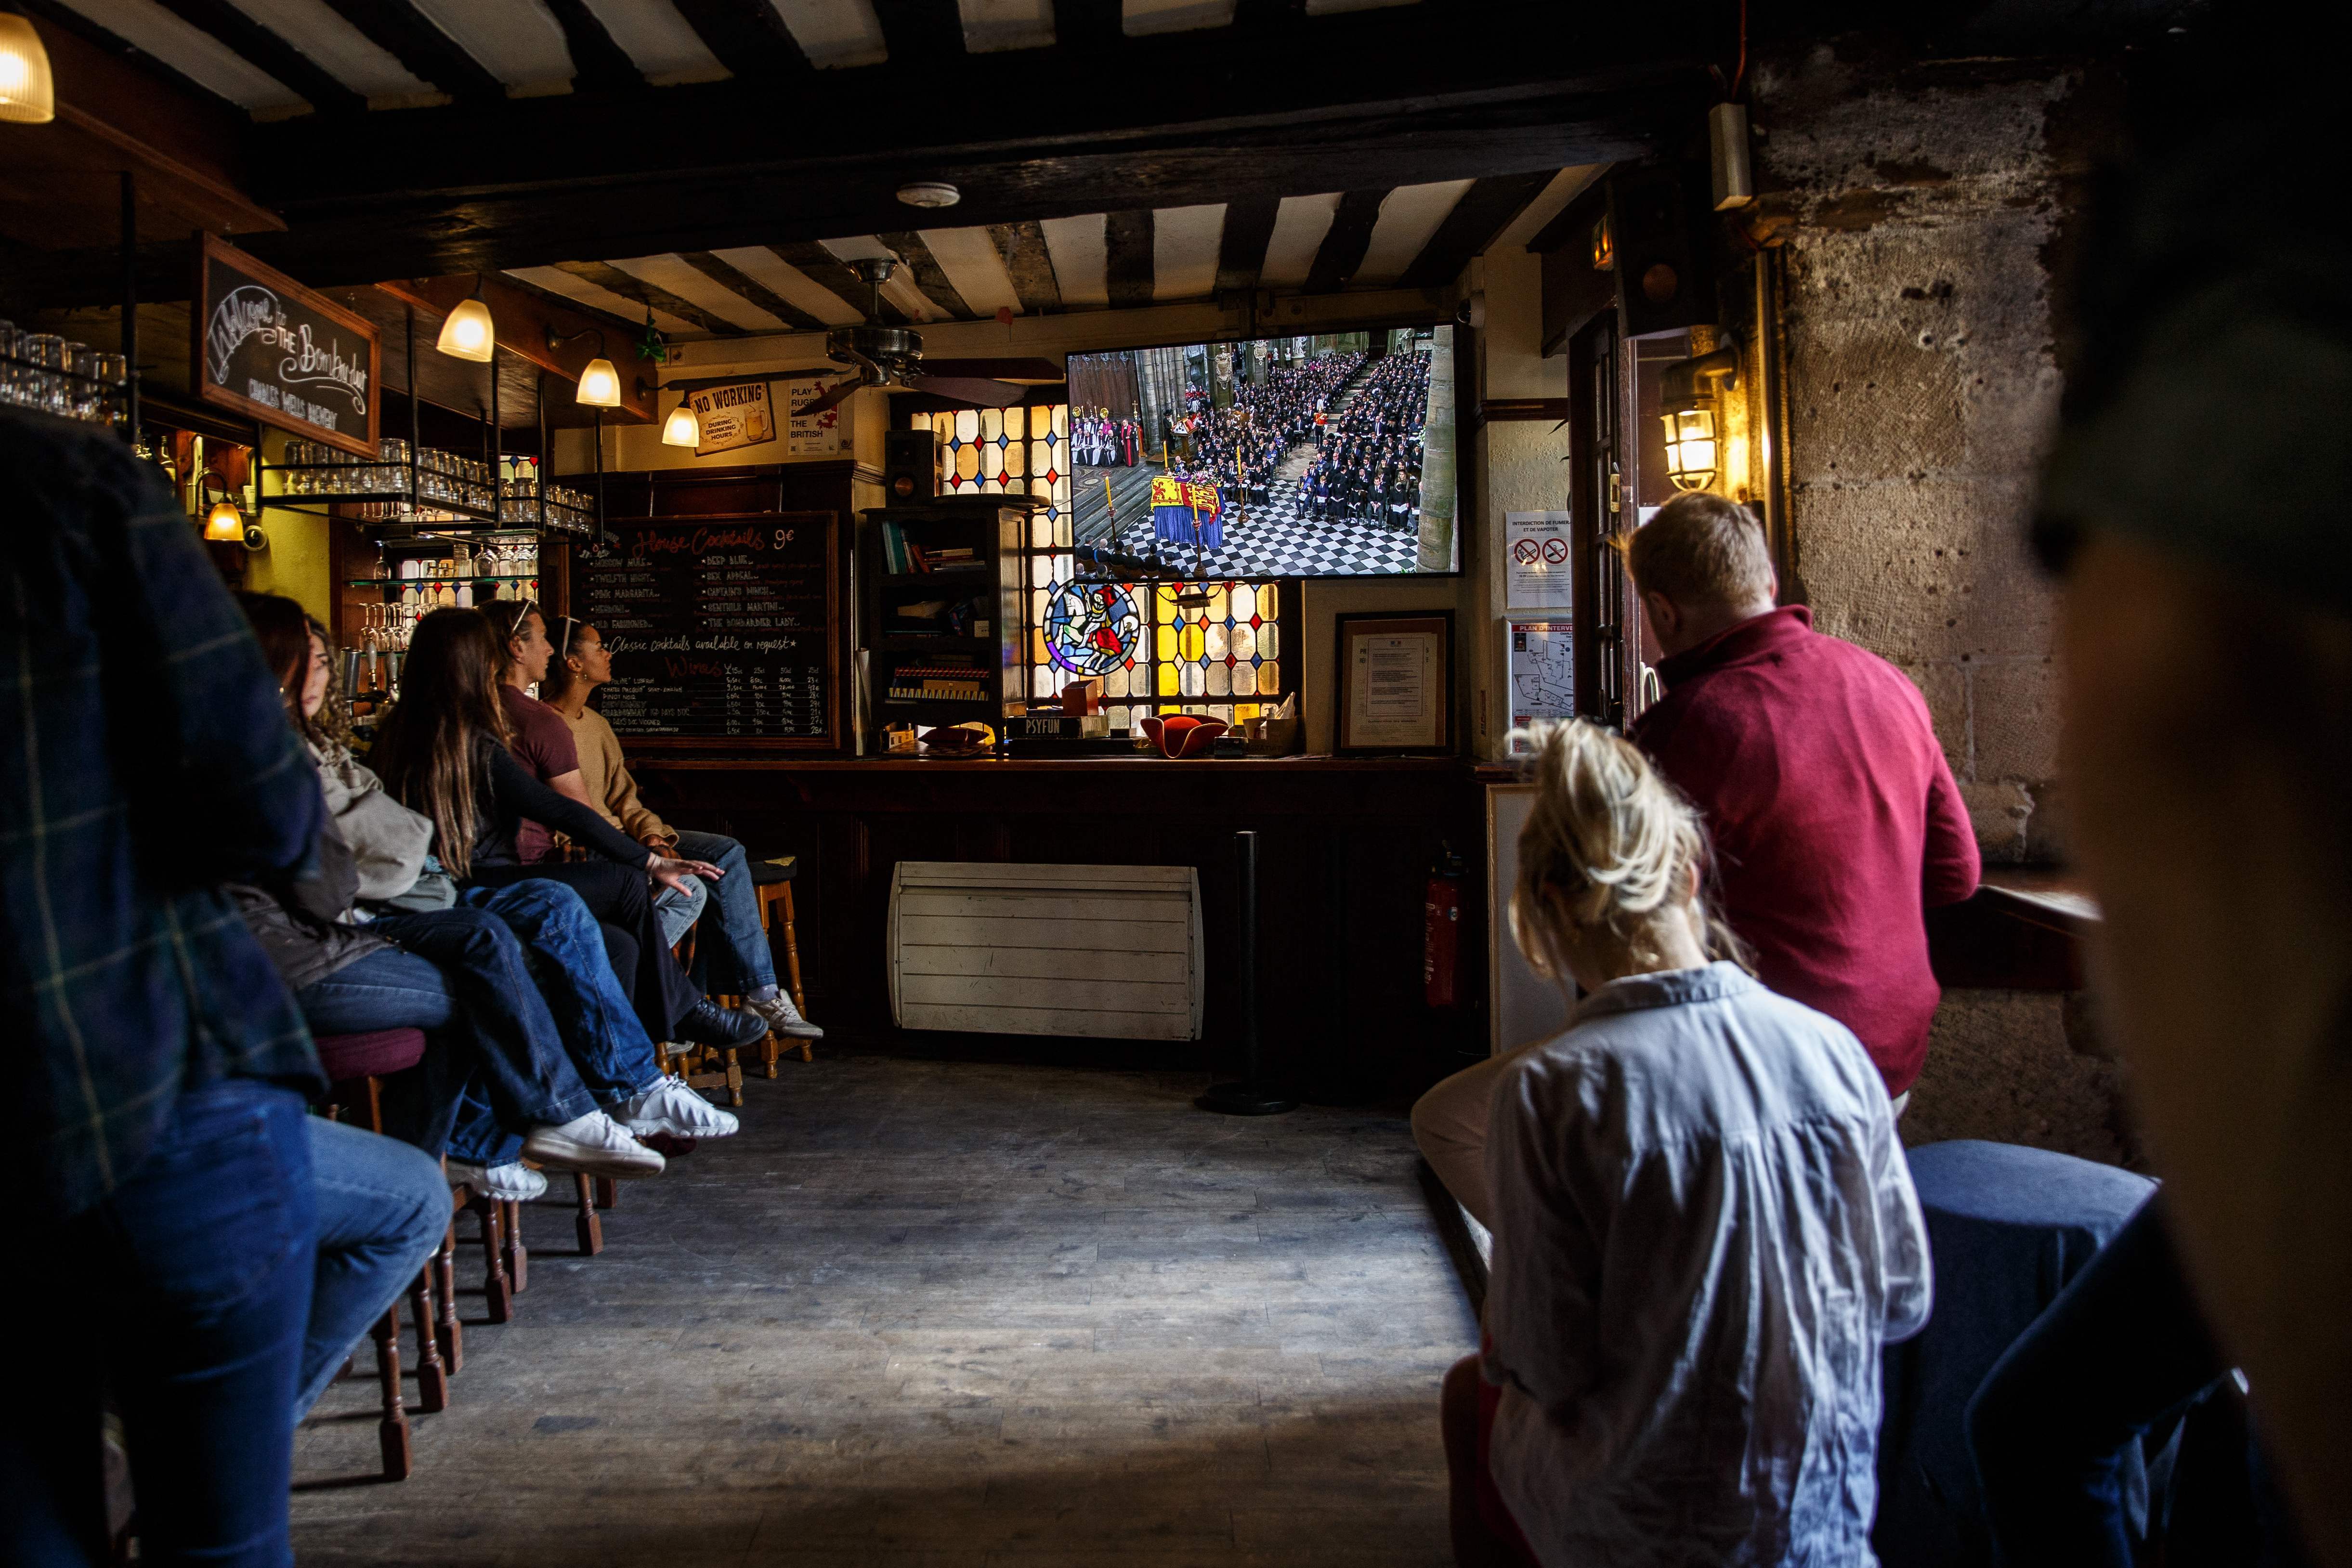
(294, 910, 595, 1157)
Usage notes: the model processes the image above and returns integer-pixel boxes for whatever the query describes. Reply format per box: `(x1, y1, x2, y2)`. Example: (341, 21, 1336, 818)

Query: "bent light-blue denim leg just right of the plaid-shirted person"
(294, 1117, 449, 1420)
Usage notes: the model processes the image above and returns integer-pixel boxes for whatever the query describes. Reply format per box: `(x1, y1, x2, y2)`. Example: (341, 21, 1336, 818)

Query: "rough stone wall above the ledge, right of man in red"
(1754, 47, 2079, 863)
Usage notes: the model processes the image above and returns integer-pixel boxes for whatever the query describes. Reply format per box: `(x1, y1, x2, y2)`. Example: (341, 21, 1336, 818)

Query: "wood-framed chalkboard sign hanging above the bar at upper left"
(191, 235, 381, 458)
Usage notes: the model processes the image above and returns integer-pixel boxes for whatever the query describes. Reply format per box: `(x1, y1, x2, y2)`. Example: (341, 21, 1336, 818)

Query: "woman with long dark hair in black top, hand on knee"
(369, 609, 767, 1046)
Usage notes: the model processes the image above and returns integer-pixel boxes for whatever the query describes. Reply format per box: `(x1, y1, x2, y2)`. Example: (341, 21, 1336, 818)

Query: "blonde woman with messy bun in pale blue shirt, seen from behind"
(1413, 722, 1931, 1568)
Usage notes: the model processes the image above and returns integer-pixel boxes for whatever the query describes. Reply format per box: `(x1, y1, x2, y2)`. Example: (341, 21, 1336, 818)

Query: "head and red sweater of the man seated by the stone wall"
(1625, 491, 1980, 1096)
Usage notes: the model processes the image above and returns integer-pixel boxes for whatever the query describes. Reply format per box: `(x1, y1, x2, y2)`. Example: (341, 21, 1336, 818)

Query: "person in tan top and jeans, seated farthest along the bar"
(538, 616, 825, 1039)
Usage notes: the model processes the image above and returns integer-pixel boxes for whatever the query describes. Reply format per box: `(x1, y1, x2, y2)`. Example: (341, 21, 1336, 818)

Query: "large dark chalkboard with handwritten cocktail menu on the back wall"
(572, 512, 842, 750)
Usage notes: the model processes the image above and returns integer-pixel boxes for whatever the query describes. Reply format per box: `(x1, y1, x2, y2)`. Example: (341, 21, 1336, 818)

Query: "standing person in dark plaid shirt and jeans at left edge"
(0, 409, 325, 1563)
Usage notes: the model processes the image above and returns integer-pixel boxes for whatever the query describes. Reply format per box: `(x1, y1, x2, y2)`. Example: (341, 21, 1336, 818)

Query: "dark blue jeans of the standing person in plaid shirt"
(0, 1079, 317, 1568)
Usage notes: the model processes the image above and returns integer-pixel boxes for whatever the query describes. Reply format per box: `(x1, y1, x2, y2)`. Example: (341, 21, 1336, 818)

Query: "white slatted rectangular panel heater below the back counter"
(889, 861, 1202, 1039)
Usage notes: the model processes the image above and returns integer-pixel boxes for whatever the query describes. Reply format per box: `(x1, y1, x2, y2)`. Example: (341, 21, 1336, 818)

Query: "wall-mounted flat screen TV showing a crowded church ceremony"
(1070, 325, 1461, 583)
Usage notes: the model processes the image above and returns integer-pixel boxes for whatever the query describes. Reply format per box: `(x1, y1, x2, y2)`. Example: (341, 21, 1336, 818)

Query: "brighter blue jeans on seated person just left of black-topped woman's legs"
(449, 877, 661, 1166)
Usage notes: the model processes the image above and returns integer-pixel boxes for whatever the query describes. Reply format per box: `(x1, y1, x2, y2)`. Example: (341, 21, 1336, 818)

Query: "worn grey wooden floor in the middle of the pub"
(294, 1056, 1477, 1568)
